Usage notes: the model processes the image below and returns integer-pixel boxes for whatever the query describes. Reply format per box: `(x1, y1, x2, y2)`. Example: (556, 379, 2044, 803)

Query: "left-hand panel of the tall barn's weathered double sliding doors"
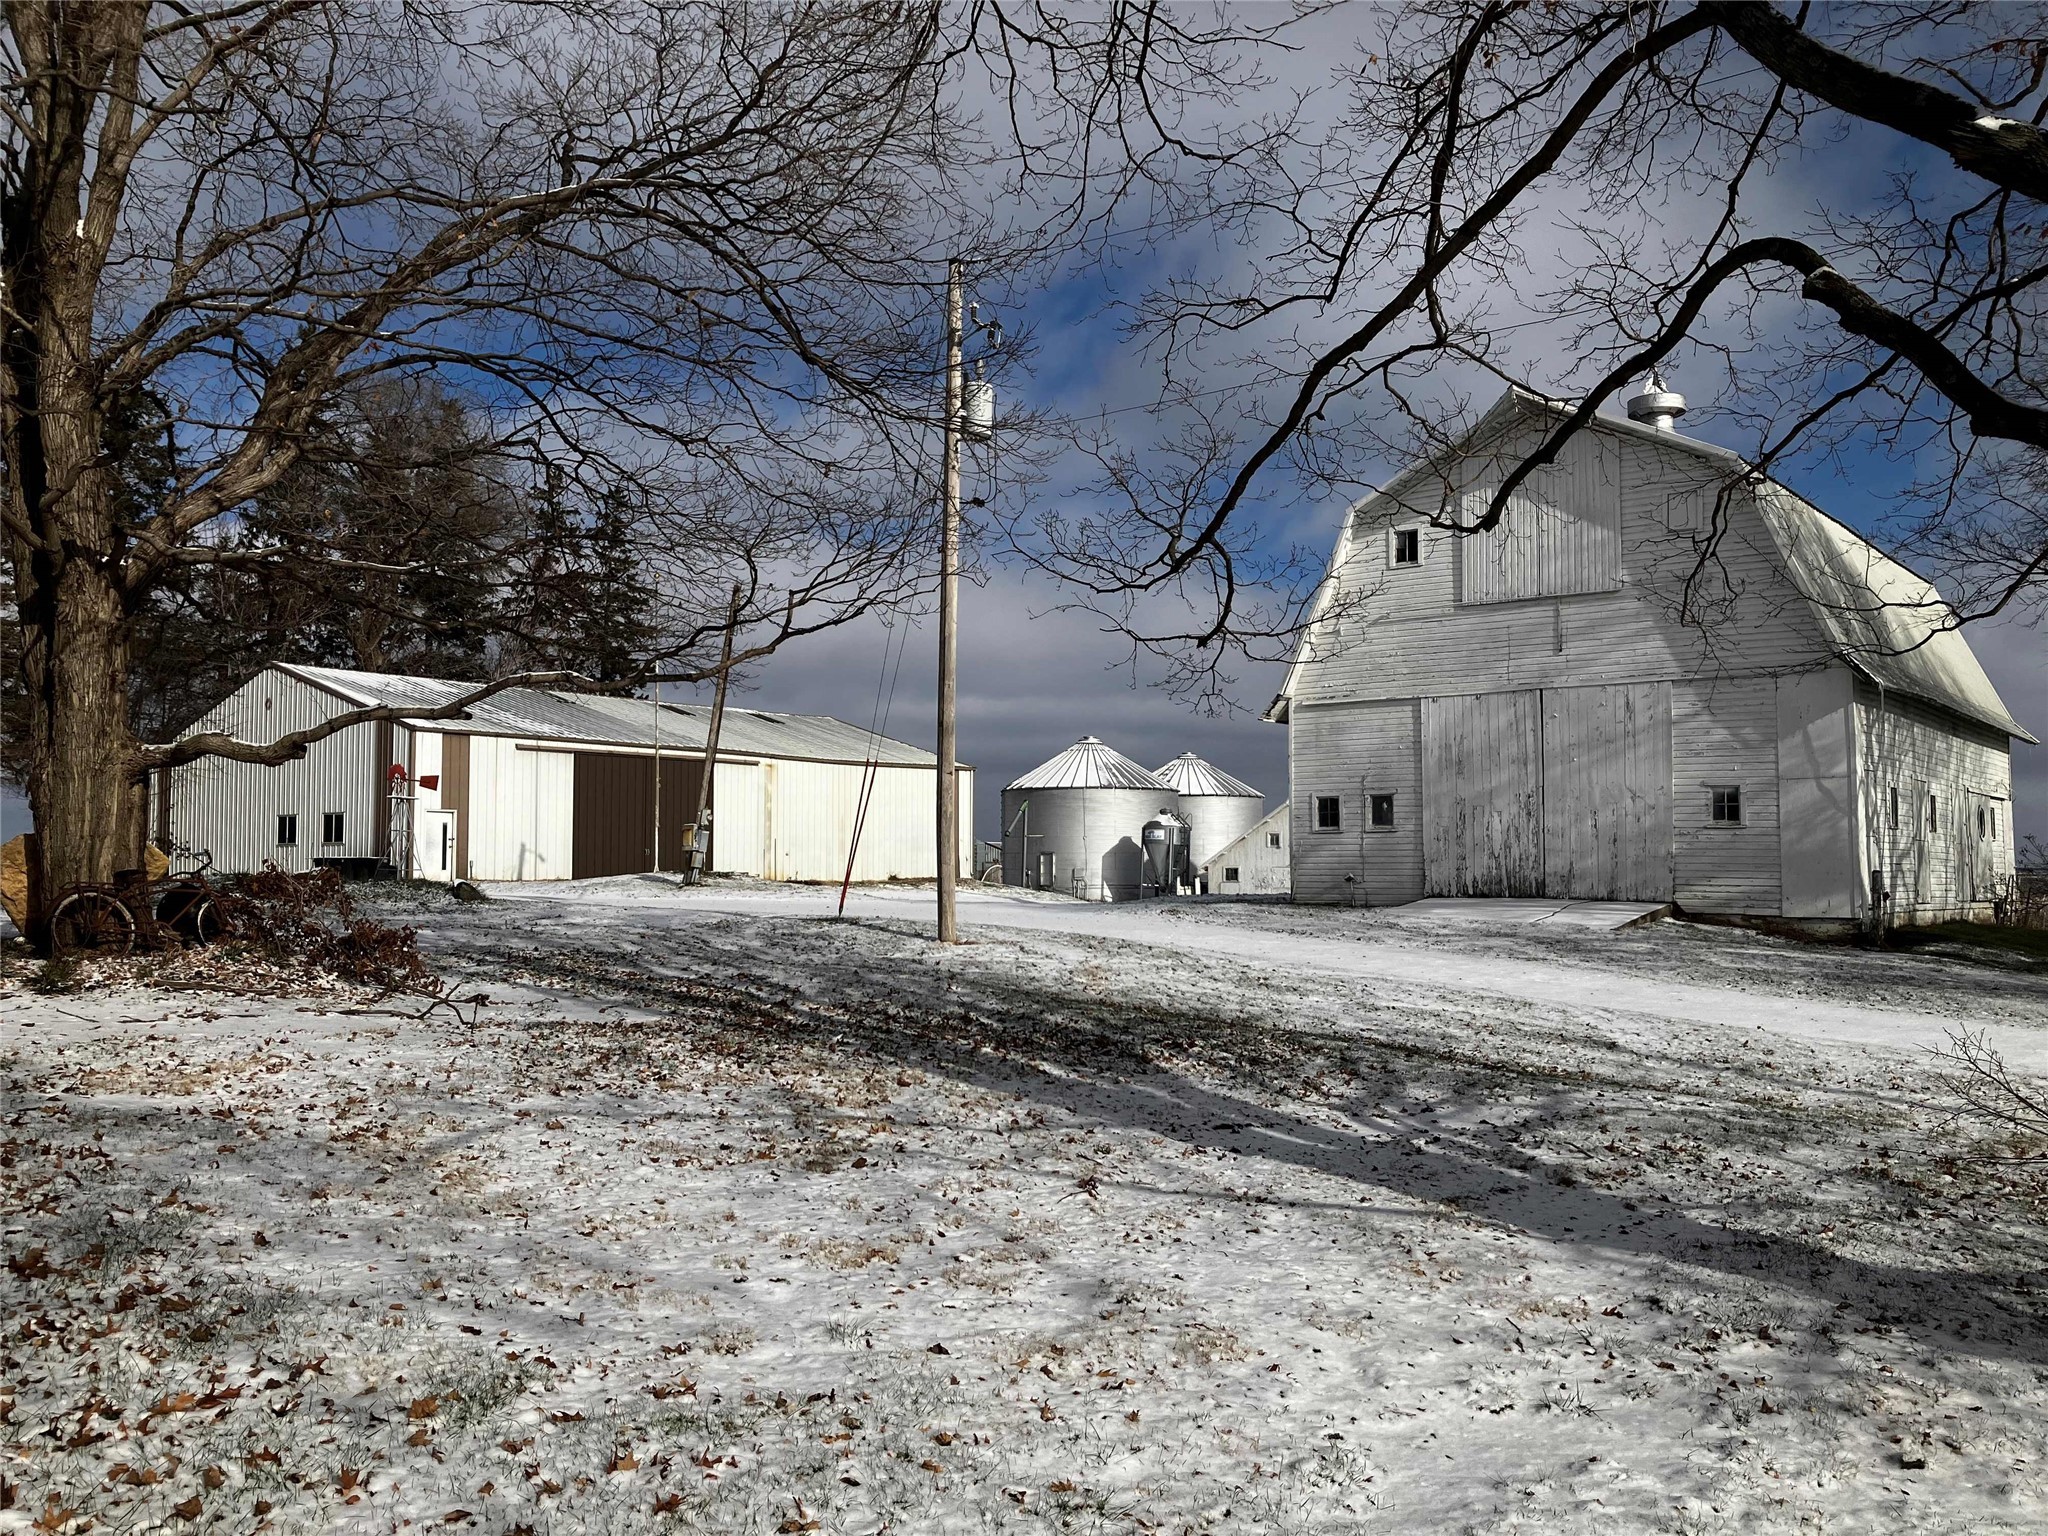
(1421, 692, 1544, 897)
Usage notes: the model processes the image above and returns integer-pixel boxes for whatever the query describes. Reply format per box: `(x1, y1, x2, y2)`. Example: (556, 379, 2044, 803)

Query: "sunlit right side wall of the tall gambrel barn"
(1855, 680, 2013, 922)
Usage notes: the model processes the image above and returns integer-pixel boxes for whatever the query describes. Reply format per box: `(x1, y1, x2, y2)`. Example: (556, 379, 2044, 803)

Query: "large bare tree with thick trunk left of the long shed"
(0, 0, 1073, 889)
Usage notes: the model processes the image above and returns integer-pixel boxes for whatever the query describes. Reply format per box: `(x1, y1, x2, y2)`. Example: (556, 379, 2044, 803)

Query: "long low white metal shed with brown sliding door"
(152, 664, 975, 881)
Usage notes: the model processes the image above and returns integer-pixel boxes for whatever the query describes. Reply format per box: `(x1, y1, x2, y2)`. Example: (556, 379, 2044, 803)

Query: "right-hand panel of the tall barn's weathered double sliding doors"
(1542, 682, 1671, 901)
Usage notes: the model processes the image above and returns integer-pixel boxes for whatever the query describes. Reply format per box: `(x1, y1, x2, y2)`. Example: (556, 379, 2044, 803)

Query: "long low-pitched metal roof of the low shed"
(274, 662, 942, 766)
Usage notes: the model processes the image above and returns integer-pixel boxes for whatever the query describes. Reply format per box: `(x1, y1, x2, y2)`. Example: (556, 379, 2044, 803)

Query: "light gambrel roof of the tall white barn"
(1266, 385, 2038, 741)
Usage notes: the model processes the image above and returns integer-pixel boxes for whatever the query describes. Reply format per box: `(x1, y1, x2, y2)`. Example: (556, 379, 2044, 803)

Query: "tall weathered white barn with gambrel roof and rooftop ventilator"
(1268, 391, 2036, 922)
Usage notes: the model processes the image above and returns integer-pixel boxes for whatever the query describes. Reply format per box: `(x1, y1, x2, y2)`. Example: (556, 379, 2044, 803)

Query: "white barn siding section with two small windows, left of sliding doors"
(1288, 698, 1423, 907)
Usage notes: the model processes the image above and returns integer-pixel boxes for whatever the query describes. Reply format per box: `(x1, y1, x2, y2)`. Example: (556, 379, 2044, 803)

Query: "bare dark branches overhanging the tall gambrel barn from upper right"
(1022, 0, 2048, 688)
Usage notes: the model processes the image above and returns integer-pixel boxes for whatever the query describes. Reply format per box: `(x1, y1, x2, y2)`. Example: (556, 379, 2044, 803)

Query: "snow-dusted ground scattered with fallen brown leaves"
(0, 881, 2048, 1534)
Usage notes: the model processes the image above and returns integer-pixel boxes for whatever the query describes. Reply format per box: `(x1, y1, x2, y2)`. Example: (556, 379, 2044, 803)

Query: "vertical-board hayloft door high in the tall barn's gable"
(1458, 432, 1622, 604)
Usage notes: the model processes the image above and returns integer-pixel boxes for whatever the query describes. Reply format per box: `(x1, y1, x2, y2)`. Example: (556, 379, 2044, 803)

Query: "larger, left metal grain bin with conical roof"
(1004, 735, 1178, 901)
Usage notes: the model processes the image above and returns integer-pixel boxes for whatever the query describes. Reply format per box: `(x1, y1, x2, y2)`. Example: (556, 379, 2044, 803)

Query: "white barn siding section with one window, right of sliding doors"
(1671, 678, 1784, 915)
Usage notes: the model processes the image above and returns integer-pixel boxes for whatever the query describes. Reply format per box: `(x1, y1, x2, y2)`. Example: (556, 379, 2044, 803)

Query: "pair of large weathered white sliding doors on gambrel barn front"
(1421, 682, 1671, 901)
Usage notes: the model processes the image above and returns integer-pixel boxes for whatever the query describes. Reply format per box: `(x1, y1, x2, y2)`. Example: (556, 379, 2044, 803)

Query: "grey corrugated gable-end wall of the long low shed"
(152, 670, 387, 872)
